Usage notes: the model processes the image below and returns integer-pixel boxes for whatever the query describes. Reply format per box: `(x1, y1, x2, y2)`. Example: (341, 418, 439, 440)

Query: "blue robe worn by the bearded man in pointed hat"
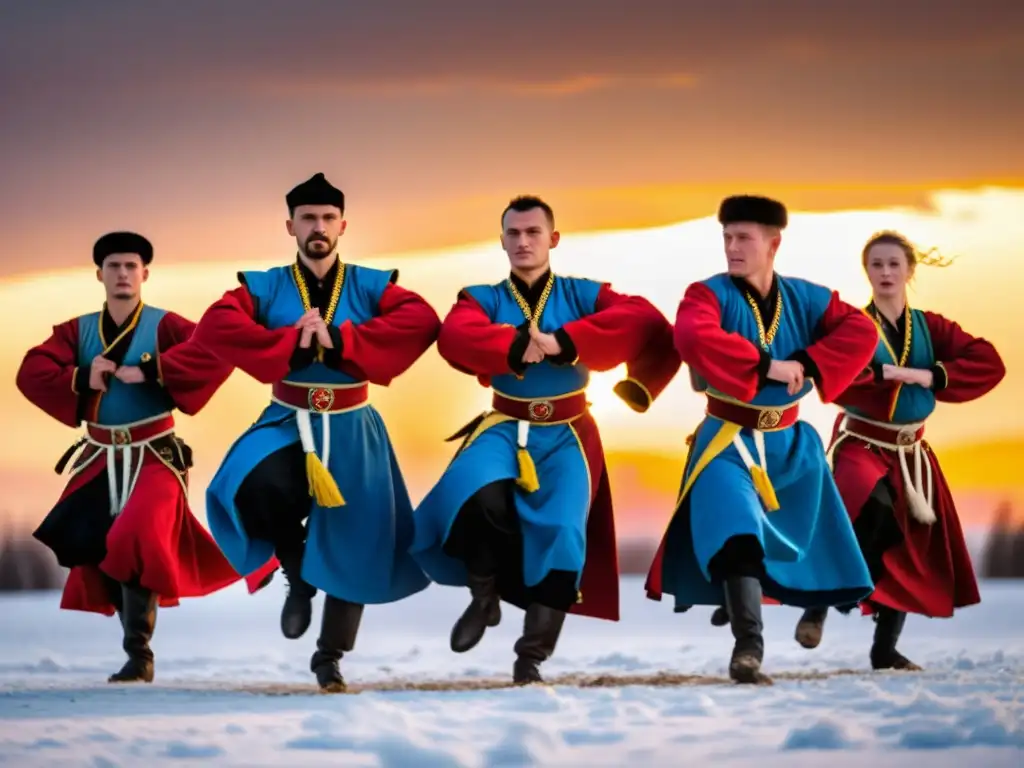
(207, 264, 430, 604)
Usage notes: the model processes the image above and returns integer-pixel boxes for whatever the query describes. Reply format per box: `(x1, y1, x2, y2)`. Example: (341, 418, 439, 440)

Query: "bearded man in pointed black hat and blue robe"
(196, 173, 440, 691)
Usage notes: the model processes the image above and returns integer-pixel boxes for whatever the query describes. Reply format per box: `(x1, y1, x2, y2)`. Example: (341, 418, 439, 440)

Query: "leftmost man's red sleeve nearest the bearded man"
(143, 312, 233, 416)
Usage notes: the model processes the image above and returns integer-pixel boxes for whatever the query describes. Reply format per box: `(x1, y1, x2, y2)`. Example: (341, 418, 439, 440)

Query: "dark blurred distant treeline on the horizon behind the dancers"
(0, 505, 1024, 592)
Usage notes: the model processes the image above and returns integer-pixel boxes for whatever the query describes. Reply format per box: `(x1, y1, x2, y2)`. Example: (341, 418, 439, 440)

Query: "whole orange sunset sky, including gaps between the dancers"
(0, 0, 1024, 536)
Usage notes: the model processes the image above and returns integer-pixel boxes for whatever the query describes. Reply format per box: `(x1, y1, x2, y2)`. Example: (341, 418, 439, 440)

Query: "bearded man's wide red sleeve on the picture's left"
(193, 286, 299, 384)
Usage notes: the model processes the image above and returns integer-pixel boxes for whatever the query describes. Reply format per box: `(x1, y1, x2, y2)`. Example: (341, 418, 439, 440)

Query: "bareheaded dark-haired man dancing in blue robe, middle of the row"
(412, 197, 680, 684)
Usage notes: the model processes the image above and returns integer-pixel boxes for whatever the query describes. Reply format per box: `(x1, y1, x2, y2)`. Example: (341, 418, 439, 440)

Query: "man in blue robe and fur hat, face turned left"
(647, 196, 877, 683)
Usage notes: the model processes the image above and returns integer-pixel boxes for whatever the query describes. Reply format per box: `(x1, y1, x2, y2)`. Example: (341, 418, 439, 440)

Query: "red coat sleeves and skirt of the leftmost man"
(16, 312, 247, 615)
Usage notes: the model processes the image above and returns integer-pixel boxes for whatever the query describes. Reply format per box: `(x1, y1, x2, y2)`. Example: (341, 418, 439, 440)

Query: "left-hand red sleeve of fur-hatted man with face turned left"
(675, 283, 771, 402)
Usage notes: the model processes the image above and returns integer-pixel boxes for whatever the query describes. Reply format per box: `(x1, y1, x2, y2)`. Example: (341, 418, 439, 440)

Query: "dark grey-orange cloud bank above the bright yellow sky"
(0, 0, 1024, 273)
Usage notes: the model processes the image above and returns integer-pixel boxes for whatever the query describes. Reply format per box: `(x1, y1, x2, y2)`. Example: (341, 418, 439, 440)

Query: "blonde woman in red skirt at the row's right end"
(797, 231, 1006, 670)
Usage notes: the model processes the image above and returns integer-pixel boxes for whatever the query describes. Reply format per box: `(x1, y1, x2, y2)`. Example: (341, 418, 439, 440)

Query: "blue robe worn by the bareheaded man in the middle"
(411, 275, 602, 606)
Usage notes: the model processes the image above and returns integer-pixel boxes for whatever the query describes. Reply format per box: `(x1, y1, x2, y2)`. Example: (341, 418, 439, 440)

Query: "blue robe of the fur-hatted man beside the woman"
(648, 274, 873, 609)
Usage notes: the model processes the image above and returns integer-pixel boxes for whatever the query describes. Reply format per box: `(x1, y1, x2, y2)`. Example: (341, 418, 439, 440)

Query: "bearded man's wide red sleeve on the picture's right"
(324, 283, 441, 386)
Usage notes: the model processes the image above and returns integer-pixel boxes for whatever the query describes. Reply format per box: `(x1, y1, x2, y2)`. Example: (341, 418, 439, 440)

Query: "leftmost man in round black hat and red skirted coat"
(17, 232, 246, 683)
